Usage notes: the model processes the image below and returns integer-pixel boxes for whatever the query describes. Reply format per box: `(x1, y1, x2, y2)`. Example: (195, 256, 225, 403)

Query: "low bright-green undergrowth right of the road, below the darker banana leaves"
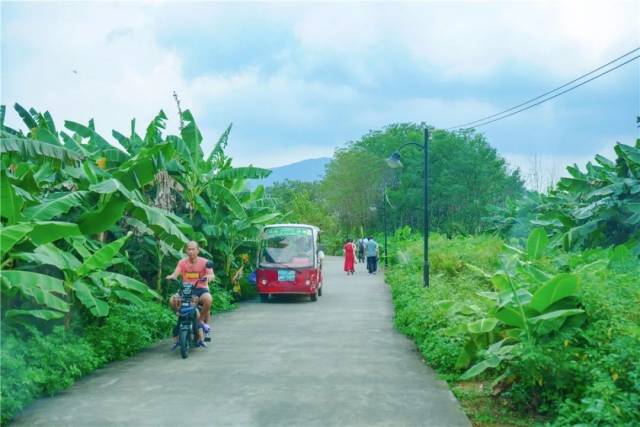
(386, 236, 640, 426)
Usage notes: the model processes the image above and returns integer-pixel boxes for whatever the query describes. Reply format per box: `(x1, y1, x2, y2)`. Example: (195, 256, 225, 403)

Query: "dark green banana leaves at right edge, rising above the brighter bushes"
(485, 140, 640, 255)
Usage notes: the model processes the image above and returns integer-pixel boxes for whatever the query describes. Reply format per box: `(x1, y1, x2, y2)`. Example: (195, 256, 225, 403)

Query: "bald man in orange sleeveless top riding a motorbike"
(167, 240, 215, 347)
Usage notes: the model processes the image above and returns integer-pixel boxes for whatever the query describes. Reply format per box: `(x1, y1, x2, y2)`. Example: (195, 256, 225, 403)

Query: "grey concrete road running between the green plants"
(13, 257, 470, 427)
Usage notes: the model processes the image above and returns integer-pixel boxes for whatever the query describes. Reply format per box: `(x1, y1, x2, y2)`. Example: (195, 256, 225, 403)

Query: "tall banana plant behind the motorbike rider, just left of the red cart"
(168, 110, 279, 290)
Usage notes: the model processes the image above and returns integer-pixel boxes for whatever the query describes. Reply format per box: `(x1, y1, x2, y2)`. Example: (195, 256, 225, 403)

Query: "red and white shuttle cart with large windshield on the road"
(256, 224, 324, 302)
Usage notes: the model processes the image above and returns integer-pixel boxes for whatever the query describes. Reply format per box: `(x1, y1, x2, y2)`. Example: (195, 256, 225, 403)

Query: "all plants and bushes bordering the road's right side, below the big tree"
(386, 136, 640, 426)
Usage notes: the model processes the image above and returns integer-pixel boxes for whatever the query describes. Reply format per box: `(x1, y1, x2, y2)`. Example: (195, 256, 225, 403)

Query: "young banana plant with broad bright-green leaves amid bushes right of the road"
(451, 229, 585, 380)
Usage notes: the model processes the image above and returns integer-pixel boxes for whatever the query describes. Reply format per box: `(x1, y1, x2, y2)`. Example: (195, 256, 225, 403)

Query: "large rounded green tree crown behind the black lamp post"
(322, 124, 523, 235)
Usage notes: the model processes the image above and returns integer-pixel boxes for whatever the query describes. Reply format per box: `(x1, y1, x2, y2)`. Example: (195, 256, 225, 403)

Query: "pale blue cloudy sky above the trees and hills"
(0, 0, 640, 186)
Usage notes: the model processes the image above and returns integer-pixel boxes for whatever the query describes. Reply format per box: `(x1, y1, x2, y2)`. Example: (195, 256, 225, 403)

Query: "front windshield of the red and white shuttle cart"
(260, 227, 314, 268)
